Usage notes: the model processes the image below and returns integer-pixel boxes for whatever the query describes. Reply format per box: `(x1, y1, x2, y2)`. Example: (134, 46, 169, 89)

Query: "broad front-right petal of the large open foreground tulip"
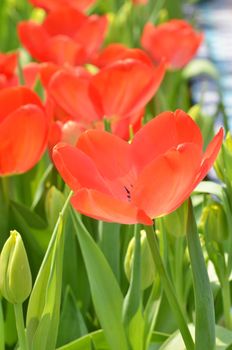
(131, 144, 202, 218)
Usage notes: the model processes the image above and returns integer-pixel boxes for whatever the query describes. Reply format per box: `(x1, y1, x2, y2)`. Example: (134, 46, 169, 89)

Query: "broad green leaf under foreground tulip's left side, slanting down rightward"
(72, 211, 128, 350)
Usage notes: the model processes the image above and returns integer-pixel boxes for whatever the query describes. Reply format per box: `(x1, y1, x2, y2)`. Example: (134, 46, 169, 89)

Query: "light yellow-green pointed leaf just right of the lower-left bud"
(26, 193, 72, 350)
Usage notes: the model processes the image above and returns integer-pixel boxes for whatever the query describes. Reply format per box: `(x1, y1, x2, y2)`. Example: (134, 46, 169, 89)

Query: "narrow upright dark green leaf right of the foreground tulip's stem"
(187, 201, 215, 350)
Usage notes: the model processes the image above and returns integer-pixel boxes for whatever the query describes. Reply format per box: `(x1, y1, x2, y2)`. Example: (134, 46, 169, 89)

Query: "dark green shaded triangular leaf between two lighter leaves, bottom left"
(57, 286, 88, 346)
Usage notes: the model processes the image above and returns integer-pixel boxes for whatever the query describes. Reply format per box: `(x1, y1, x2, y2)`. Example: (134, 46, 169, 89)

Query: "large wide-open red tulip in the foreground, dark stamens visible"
(53, 110, 223, 225)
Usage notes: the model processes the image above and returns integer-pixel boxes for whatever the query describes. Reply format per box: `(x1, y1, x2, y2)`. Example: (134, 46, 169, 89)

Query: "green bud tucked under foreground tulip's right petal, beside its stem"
(163, 201, 188, 237)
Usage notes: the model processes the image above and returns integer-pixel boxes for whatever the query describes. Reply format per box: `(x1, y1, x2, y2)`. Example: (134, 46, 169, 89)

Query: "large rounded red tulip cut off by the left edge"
(0, 86, 48, 175)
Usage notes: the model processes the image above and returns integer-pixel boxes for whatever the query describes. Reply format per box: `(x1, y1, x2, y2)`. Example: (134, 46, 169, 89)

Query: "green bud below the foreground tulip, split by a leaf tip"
(124, 230, 155, 289)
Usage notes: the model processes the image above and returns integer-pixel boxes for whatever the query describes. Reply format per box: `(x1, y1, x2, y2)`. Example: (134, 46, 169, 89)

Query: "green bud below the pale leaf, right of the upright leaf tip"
(200, 202, 229, 242)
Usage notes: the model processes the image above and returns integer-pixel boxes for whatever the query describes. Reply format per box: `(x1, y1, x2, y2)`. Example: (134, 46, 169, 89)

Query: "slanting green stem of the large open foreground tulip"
(145, 226, 194, 350)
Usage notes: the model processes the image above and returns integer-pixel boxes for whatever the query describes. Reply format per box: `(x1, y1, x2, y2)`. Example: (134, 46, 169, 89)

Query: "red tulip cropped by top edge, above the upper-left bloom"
(30, 0, 96, 11)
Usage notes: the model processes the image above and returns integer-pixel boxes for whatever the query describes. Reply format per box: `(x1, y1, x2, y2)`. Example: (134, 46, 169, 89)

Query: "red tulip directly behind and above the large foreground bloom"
(48, 59, 164, 139)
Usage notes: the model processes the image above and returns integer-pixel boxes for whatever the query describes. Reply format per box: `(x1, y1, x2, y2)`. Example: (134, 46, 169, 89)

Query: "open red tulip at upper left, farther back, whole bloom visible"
(18, 7, 107, 65)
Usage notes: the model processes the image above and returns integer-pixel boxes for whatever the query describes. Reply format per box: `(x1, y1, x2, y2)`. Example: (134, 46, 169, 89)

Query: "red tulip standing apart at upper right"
(141, 19, 203, 69)
